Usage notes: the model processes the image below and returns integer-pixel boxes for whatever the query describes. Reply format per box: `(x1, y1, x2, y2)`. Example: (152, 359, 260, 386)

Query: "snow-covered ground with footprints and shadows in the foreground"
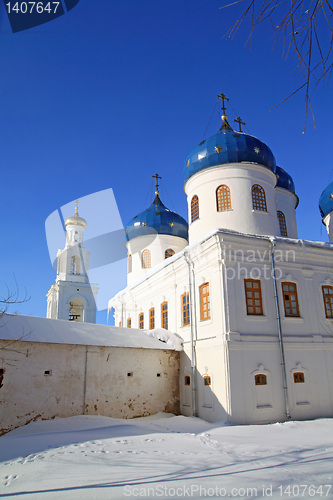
(0, 414, 333, 500)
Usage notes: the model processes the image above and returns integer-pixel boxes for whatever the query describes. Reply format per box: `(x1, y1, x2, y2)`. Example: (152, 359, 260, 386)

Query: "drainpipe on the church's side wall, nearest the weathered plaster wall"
(184, 252, 197, 417)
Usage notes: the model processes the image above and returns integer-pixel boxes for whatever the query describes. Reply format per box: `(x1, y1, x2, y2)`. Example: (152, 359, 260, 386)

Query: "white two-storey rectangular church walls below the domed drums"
(110, 230, 333, 423)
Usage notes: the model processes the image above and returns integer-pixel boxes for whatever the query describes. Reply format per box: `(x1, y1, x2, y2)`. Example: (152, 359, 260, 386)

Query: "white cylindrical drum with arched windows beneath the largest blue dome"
(184, 163, 280, 244)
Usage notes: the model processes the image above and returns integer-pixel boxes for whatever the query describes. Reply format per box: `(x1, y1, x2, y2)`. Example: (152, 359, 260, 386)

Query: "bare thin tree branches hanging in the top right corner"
(220, 0, 333, 130)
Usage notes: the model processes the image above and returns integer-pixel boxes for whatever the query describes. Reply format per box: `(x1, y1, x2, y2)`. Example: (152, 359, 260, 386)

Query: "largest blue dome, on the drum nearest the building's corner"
(183, 122, 276, 182)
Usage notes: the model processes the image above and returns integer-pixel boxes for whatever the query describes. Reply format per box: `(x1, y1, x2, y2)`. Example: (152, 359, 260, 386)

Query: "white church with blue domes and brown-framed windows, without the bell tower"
(109, 94, 333, 424)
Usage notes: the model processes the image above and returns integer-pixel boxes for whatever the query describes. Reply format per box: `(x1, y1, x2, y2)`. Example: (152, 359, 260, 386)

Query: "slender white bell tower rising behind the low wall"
(47, 200, 98, 323)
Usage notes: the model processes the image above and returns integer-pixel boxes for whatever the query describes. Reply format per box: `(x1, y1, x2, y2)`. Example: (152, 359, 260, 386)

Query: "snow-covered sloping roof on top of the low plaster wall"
(0, 314, 182, 351)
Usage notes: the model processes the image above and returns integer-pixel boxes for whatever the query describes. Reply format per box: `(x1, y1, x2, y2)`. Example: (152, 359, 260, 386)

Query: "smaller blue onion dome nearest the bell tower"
(126, 195, 188, 241)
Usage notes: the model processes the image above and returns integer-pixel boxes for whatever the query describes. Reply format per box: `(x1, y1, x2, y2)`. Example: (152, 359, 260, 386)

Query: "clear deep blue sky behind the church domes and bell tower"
(0, 0, 333, 322)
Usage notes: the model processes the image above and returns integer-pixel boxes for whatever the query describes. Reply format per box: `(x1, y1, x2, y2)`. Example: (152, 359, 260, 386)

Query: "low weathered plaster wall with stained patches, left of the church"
(0, 340, 179, 434)
